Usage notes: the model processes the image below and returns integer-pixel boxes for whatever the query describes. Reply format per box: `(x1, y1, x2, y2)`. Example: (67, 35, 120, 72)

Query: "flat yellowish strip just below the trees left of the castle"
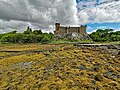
(0, 44, 61, 51)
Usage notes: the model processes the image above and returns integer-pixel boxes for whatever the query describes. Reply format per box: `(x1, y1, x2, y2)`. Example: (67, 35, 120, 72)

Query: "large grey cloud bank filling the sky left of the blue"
(0, 0, 78, 33)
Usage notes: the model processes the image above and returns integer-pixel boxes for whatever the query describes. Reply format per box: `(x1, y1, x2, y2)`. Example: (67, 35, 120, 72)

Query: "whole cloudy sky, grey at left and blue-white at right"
(0, 0, 120, 33)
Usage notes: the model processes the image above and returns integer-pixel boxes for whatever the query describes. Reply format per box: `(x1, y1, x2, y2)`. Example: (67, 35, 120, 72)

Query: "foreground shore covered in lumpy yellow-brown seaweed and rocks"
(0, 45, 120, 90)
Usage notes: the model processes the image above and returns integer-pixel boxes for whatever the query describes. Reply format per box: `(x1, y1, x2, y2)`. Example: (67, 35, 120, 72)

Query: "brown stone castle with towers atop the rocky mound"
(54, 23, 87, 36)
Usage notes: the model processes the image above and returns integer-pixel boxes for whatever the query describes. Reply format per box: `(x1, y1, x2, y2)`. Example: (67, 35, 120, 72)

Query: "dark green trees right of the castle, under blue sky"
(90, 29, 120, 42)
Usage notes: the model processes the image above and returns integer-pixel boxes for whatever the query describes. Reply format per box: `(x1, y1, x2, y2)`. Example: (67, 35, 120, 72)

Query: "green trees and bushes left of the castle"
(0, 27, 53, 44)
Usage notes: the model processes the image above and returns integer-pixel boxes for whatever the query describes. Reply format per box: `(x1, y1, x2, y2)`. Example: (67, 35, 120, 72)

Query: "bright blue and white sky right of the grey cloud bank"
(76, 0, 120, 33)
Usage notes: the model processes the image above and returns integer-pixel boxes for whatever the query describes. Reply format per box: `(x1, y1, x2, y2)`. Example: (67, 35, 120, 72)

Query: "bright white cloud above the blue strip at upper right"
(78, 0, 120, 24)
